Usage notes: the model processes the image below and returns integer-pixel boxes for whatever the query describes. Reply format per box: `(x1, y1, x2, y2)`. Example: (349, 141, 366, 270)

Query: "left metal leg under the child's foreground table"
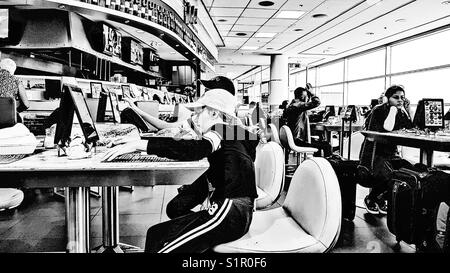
(65, 187, 90, 253)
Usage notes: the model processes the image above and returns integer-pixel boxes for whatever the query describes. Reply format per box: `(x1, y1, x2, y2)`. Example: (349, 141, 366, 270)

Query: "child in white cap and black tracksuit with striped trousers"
(104, 89, 259, 253)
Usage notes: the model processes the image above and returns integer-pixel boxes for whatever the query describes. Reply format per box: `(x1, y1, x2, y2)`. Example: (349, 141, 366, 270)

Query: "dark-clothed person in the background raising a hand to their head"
(282, 87, 332, 157)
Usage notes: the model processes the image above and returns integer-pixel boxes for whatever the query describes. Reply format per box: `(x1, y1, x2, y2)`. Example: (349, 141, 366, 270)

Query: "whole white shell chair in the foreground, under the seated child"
(213, 157, 342, 253)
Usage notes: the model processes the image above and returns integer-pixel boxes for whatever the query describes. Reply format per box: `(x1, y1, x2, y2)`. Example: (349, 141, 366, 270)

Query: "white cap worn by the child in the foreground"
(184, 89, 237, 119)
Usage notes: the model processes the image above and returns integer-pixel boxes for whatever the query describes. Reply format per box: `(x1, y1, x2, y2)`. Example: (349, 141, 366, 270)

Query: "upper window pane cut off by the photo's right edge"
(391, 30, 450, 73)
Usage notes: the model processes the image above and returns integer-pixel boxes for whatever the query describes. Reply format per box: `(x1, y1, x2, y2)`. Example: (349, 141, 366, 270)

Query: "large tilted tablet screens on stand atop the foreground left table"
(54, 84, 99, 146)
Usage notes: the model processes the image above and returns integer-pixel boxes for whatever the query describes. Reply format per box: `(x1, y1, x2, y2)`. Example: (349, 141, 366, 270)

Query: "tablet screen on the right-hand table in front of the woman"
(413, 98, 445, 130)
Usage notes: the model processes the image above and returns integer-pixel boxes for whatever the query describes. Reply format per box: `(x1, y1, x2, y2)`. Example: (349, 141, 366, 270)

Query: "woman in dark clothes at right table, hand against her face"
(360, 85, 413, 214)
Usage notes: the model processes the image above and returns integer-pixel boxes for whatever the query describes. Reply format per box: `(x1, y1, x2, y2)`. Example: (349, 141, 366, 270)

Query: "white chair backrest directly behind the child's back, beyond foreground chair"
(255, 142, 284, 209)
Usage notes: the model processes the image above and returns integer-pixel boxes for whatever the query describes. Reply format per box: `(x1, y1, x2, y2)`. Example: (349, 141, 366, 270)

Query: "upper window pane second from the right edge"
(348, 49, 386, 81)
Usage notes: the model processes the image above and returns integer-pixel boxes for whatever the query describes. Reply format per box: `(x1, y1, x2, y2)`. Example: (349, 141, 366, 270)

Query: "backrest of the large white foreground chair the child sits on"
(283, 157, 342, 249)
